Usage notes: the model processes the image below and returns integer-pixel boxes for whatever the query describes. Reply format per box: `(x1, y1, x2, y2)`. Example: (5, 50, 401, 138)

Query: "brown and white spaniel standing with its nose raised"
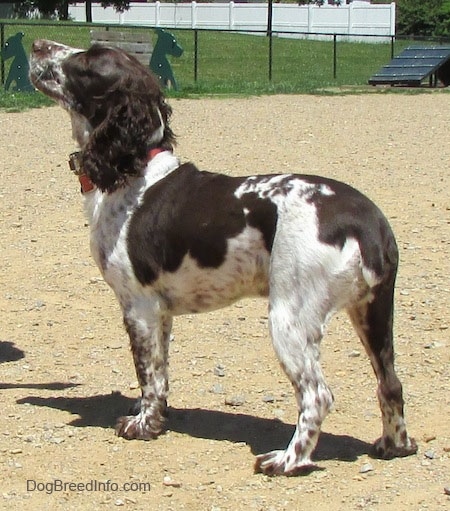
(30, 40, 417, 476)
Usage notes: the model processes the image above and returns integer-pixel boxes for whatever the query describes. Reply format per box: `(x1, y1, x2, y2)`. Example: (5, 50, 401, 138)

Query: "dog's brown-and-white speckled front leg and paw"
(116, 300, 172, 440)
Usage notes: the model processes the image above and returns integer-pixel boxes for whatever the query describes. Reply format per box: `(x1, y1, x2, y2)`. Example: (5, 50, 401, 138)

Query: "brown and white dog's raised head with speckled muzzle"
(30, 40, 175, 192)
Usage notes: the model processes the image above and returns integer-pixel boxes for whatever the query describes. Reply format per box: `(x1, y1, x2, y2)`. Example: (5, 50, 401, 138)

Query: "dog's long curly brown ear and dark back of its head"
(74, 48, 175, 192)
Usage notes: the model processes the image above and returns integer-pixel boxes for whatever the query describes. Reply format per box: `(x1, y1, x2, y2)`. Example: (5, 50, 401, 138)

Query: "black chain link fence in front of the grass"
(0, 20, 449, 93)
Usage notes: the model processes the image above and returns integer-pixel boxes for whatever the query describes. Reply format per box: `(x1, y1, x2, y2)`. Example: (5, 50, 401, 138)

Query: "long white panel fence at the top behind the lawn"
(69, 1, 395, 42)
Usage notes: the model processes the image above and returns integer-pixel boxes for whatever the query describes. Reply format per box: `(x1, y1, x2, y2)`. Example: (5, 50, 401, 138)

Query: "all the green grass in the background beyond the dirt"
(0, 22, 448, 111)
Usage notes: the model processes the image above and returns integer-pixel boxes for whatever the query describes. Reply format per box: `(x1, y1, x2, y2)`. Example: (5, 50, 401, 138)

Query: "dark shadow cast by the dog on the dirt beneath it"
(17, 392, 371, 461)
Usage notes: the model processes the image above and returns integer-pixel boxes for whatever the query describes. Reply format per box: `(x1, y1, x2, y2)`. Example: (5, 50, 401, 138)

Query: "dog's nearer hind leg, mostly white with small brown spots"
(255, 290, 333, 476)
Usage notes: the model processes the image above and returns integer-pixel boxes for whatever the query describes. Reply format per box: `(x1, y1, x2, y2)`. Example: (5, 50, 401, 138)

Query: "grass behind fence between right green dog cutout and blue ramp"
(172, 32, 390, 94)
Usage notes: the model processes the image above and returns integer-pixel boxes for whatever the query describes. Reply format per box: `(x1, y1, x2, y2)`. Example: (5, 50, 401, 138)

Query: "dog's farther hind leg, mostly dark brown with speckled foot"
(347, 269, 417, 459)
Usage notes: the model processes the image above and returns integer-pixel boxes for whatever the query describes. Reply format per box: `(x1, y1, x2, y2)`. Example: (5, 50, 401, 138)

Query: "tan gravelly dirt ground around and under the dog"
(0, 92, 450, 511)
